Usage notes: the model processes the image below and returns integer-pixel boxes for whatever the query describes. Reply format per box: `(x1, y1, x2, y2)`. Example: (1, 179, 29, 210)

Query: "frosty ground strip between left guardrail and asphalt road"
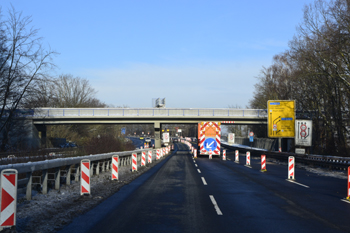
(2, 155, 168, 233)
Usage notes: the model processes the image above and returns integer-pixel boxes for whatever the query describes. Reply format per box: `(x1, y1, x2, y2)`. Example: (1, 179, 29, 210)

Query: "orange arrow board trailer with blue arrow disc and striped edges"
(198, 122, 221, 155)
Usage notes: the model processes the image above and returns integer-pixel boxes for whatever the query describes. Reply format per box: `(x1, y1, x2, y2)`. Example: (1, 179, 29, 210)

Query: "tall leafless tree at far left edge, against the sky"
(0, 7, 54, 149)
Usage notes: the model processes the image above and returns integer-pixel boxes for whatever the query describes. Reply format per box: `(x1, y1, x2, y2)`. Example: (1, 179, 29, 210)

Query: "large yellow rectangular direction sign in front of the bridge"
(267, 100, 295, 138)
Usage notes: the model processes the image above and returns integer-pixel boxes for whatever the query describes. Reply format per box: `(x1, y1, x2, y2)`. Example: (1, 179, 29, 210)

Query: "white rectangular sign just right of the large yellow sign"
(295, 120, 312, 146)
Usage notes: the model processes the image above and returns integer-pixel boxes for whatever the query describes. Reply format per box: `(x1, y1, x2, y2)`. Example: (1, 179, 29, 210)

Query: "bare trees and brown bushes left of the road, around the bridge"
(0, 7, 135, 153)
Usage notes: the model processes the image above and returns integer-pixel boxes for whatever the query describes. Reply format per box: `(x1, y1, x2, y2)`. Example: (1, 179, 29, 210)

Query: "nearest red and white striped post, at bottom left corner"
(0, 169, 18, 227)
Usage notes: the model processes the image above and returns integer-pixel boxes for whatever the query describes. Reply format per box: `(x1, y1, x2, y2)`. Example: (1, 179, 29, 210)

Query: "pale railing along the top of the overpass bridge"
(30, 108, 267, 118)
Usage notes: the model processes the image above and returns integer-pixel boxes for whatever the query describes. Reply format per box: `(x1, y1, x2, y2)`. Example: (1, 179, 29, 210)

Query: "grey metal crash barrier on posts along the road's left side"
(0, 149, 161, 200)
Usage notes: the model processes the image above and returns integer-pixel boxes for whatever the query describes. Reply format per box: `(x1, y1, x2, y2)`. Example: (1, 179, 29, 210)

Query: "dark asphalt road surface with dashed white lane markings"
(61, 143, 350, 233)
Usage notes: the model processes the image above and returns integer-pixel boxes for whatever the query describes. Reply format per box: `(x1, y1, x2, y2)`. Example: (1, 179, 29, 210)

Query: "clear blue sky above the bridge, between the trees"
(0, 0, 313, 108)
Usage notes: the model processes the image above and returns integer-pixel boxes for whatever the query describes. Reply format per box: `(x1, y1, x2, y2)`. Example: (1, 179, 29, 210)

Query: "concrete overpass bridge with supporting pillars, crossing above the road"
(23, 108, 267, 148)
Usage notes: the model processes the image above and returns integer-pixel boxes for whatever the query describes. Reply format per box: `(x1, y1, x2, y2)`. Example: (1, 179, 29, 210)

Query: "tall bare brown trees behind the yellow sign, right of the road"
(250, 0, 350, 156)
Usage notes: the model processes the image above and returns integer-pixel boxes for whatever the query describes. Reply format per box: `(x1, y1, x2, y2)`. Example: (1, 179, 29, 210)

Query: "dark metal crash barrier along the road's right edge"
(221, 142, 350, 170)
